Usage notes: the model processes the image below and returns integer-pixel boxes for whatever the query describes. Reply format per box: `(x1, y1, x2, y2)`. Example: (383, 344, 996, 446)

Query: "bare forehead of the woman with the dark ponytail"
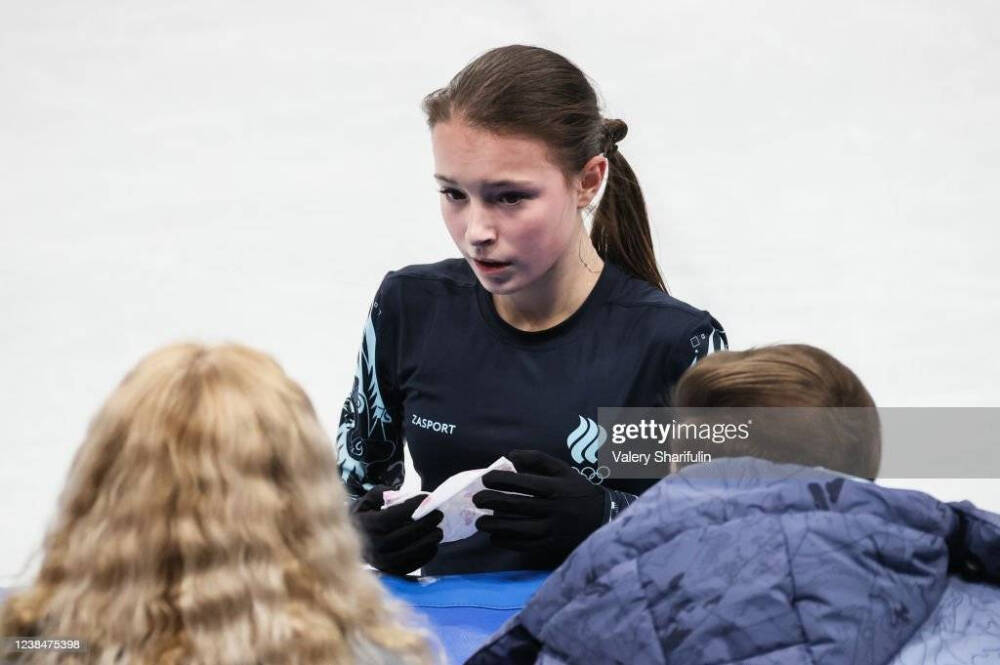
(431, 119, 562, 185)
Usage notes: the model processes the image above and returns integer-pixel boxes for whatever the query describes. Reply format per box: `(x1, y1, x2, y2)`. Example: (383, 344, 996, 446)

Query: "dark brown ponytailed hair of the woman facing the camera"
(422, 44, 667, 291)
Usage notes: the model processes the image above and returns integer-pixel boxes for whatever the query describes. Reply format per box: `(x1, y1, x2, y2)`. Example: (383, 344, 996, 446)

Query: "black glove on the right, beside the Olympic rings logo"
(472, 450, 610, 566)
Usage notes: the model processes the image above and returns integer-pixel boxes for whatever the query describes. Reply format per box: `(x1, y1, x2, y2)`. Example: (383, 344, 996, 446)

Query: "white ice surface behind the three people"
(0, 0, 1000, 584)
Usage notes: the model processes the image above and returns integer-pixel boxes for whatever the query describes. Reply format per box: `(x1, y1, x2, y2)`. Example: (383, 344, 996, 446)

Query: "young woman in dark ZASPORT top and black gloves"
(337, 45, 726, 573)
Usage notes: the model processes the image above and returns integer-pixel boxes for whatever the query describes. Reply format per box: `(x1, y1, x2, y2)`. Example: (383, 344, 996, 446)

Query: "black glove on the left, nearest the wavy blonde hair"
(351, 485, 444, 575)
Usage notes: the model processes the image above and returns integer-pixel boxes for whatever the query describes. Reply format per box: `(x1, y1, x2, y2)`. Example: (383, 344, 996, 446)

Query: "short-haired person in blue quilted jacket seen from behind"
(466, 344, 1000, 665)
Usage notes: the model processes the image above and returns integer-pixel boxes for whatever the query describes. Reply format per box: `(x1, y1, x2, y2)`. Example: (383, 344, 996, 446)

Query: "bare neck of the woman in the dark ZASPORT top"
(493, 223, 604, 332)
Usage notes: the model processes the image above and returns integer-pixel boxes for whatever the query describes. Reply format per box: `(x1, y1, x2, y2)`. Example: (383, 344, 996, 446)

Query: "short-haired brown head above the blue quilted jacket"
(671, 344, 882, 479)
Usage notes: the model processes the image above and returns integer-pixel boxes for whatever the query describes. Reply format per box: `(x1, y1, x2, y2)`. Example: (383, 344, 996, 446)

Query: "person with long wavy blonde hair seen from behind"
(0, 344, 438, 665)
